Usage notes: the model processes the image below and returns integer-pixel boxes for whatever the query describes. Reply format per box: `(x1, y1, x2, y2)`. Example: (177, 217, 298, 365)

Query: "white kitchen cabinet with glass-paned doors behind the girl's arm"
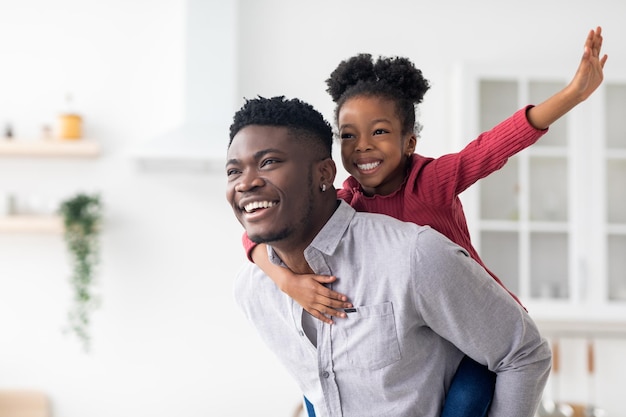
(456, 67, 626, 329)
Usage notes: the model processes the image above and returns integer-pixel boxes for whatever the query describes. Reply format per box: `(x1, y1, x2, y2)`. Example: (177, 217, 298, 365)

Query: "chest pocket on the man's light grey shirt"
(342, 302, 401, 370)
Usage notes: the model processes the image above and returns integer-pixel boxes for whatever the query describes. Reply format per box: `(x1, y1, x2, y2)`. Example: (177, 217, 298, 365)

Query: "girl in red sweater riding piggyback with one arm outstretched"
(244, 27, 607, 417)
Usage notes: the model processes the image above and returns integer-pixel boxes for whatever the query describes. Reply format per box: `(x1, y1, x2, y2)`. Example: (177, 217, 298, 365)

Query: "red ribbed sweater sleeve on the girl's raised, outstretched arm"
(410, 106, 547, 205)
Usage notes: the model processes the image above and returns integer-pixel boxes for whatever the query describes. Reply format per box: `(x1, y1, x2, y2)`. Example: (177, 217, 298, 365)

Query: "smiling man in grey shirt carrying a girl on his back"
(226, 97, 551, 417)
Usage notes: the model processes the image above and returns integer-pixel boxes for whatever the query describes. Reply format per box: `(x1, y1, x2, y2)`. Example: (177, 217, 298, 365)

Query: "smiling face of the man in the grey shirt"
(226, 125, 313, 243)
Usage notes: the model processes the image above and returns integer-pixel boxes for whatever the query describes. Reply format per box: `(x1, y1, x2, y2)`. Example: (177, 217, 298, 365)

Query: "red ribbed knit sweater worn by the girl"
(243, 107, 547, 302)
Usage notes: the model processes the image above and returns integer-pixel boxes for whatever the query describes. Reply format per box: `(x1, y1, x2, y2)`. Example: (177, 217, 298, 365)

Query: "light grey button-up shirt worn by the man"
(235, 201, 551, 417)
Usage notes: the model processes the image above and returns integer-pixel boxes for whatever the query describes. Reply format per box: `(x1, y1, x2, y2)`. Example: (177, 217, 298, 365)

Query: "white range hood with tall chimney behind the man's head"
(132, 0, 237, 169)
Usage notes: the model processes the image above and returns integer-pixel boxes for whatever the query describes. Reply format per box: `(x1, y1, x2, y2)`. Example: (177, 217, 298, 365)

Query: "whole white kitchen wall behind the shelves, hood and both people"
(0, 0, 626, 417)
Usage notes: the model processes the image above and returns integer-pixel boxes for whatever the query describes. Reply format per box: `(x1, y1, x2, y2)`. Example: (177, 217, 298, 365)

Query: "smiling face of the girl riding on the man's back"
(337, 96, 417, 196)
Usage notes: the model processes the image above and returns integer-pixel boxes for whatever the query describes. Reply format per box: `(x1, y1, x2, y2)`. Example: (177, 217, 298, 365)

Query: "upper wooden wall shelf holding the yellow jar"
(0, 139, 100, 158)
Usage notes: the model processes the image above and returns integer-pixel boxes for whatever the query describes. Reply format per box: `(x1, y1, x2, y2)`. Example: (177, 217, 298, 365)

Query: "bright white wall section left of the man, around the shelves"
(0, 0, 299, 417)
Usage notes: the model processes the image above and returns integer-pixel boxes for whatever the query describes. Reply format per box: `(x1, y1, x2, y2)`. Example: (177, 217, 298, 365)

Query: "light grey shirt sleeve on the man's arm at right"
(415, 229, 551, 417)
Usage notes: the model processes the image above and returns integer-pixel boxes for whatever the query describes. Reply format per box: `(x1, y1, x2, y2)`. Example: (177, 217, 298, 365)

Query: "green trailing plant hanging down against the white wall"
(59, 193, 102, 351)
